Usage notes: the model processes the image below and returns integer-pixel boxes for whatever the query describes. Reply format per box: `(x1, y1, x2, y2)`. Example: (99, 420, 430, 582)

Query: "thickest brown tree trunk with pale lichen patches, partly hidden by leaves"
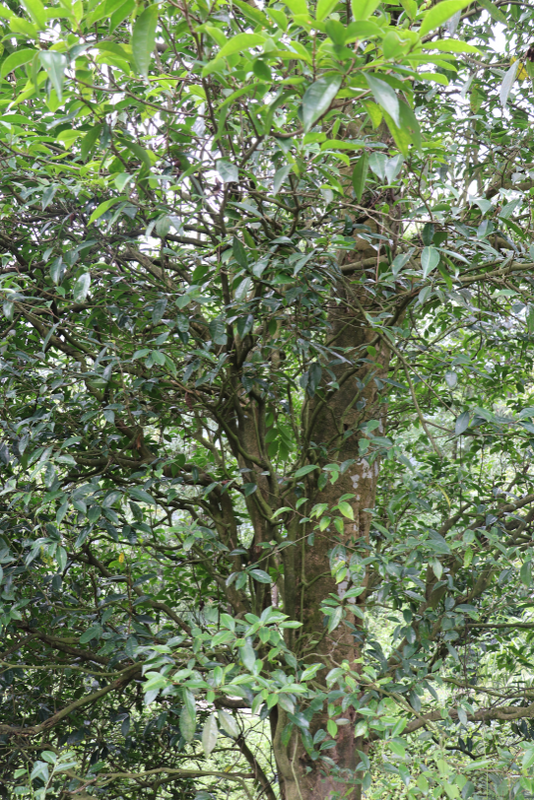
(274, 260, 389, 800)
